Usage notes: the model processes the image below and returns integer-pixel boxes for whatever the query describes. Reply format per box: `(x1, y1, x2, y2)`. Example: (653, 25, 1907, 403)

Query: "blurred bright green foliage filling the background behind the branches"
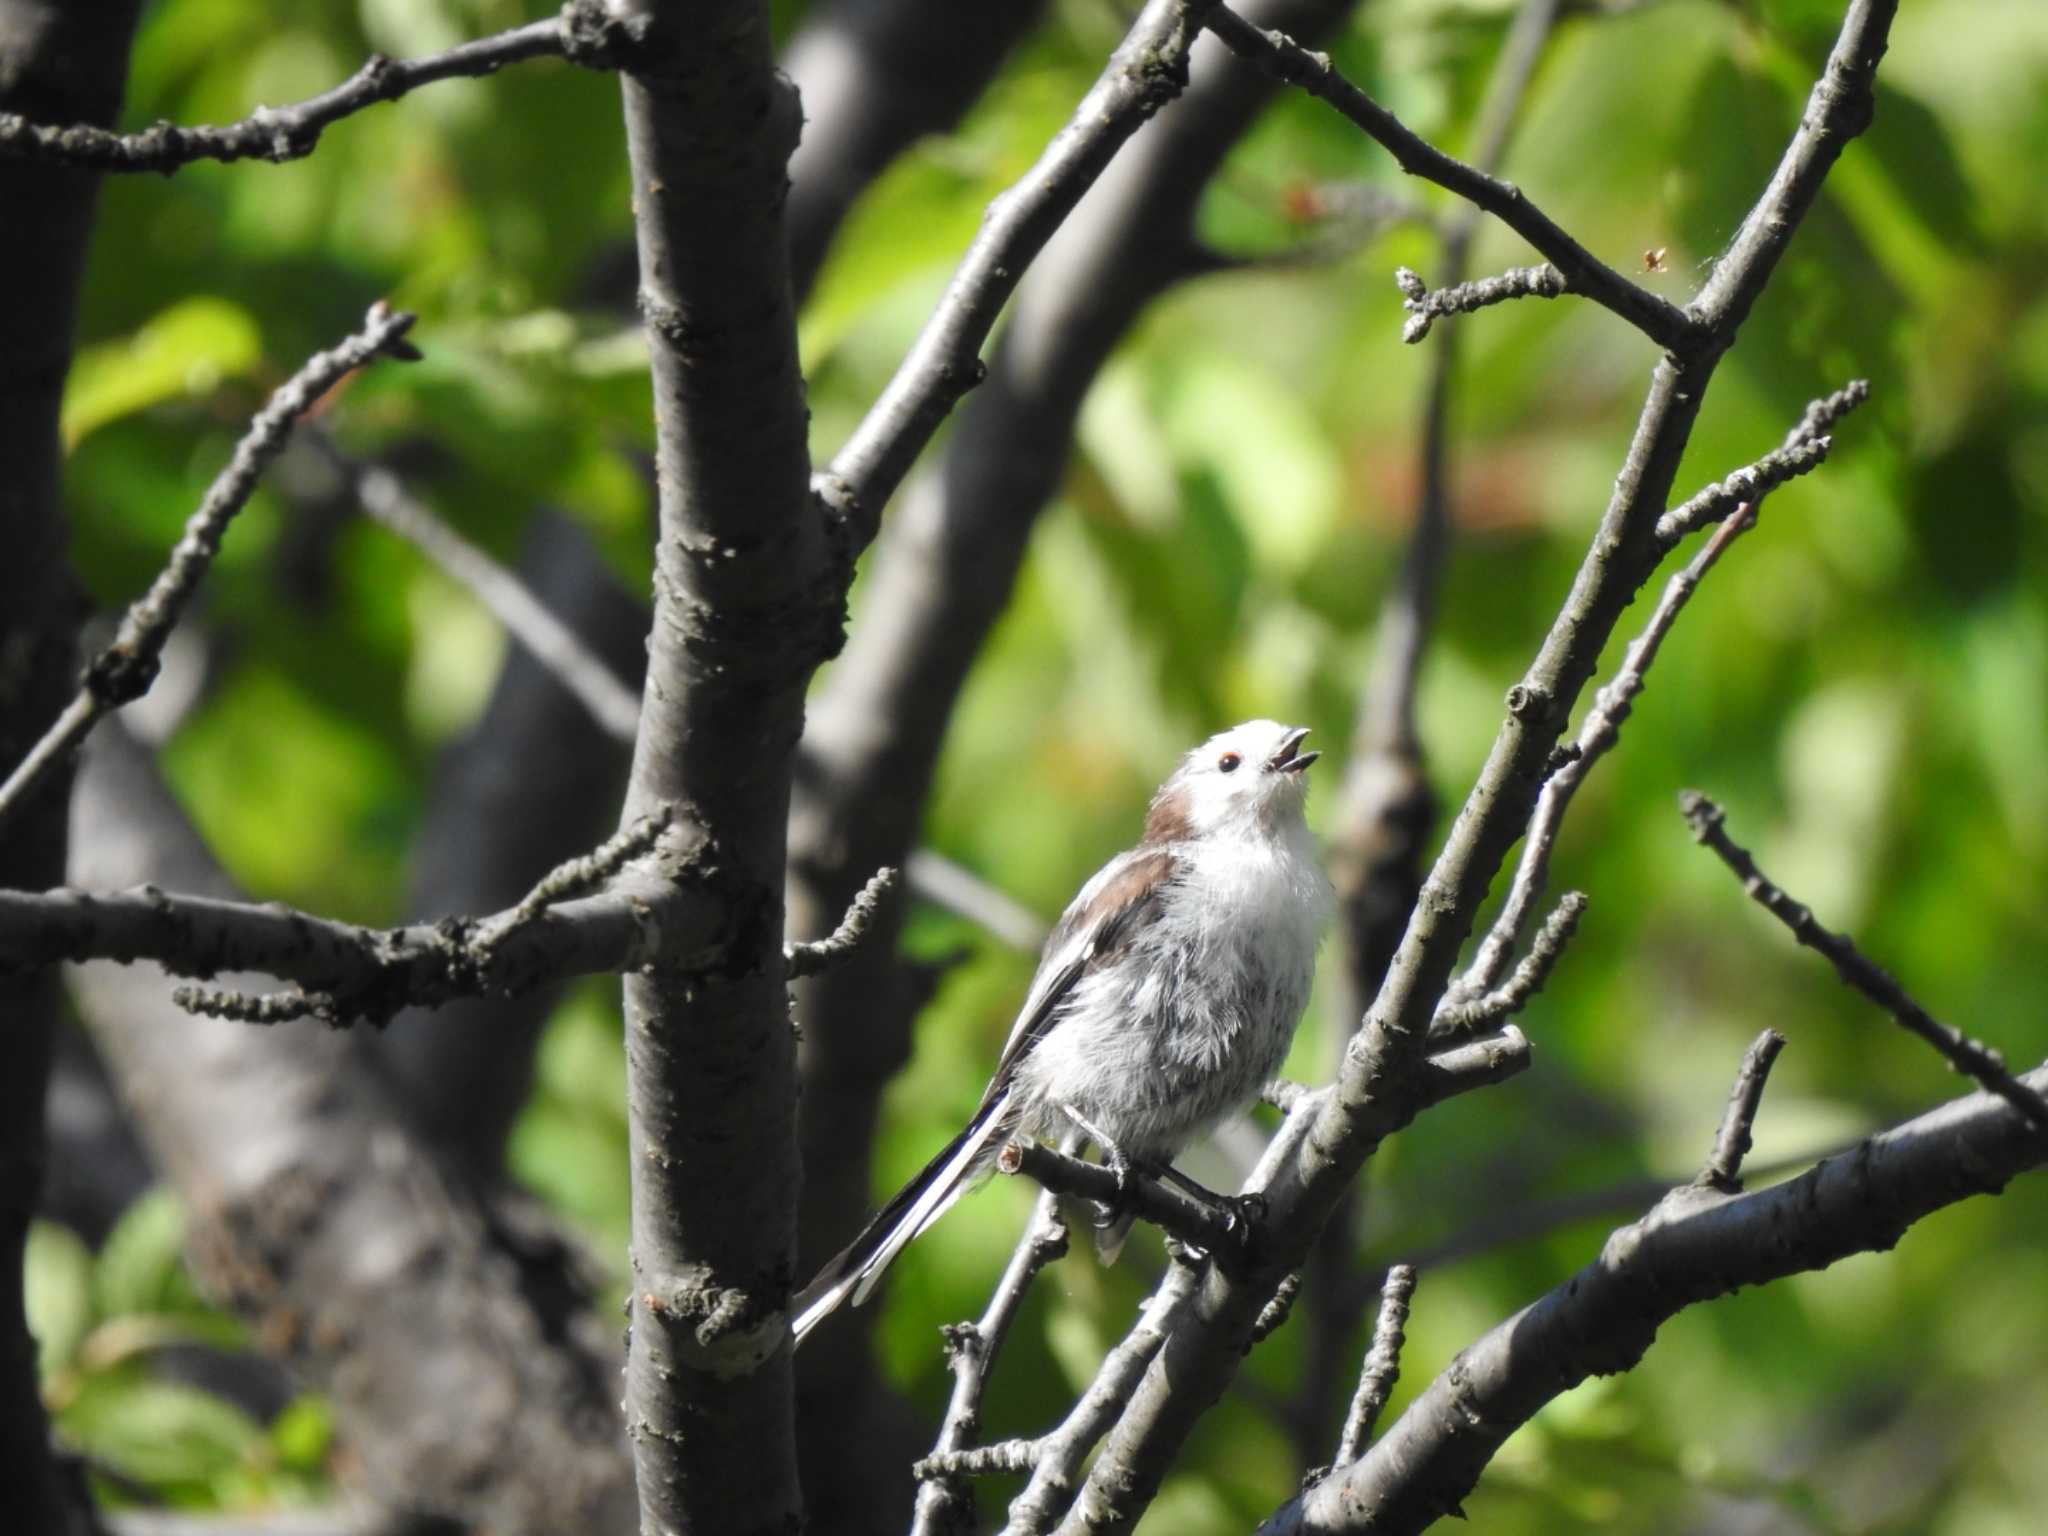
(31, 0, 2048, 1536)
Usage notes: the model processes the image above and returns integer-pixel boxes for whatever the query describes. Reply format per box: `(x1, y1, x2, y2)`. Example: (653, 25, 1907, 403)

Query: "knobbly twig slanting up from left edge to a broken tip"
(0, 299, 420, 821)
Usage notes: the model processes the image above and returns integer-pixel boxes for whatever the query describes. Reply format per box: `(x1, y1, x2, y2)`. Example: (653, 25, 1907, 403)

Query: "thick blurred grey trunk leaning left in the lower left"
(70, 725, 633, 1536)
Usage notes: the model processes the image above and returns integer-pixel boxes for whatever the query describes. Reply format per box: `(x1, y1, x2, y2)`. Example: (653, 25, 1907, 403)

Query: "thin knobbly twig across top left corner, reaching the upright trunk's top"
(0, 0, 623, 174)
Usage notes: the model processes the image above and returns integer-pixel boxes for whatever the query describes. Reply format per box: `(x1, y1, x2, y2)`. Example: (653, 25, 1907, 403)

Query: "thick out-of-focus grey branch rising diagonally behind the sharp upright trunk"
(788, 0, 1352, 1524)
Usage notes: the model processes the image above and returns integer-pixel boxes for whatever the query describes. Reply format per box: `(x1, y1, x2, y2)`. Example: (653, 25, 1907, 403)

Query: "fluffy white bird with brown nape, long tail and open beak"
(793, 721, 1331, 1343)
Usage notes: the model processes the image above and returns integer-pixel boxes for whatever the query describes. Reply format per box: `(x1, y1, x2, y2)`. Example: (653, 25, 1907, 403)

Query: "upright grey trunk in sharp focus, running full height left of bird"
(608, 0, 831, 1536)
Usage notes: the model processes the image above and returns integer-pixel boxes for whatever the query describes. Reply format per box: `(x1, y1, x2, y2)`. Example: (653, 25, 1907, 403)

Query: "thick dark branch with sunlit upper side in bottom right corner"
(1260, 1069, 2048, 1536)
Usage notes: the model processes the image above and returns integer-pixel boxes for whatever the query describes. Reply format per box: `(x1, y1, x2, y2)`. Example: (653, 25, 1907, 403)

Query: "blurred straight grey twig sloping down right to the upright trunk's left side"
(307, 430, 639, 745)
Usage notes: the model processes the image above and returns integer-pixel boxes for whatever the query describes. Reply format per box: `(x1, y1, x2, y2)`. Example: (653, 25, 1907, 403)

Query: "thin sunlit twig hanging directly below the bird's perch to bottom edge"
(911, 1190, 1067, 1536)
